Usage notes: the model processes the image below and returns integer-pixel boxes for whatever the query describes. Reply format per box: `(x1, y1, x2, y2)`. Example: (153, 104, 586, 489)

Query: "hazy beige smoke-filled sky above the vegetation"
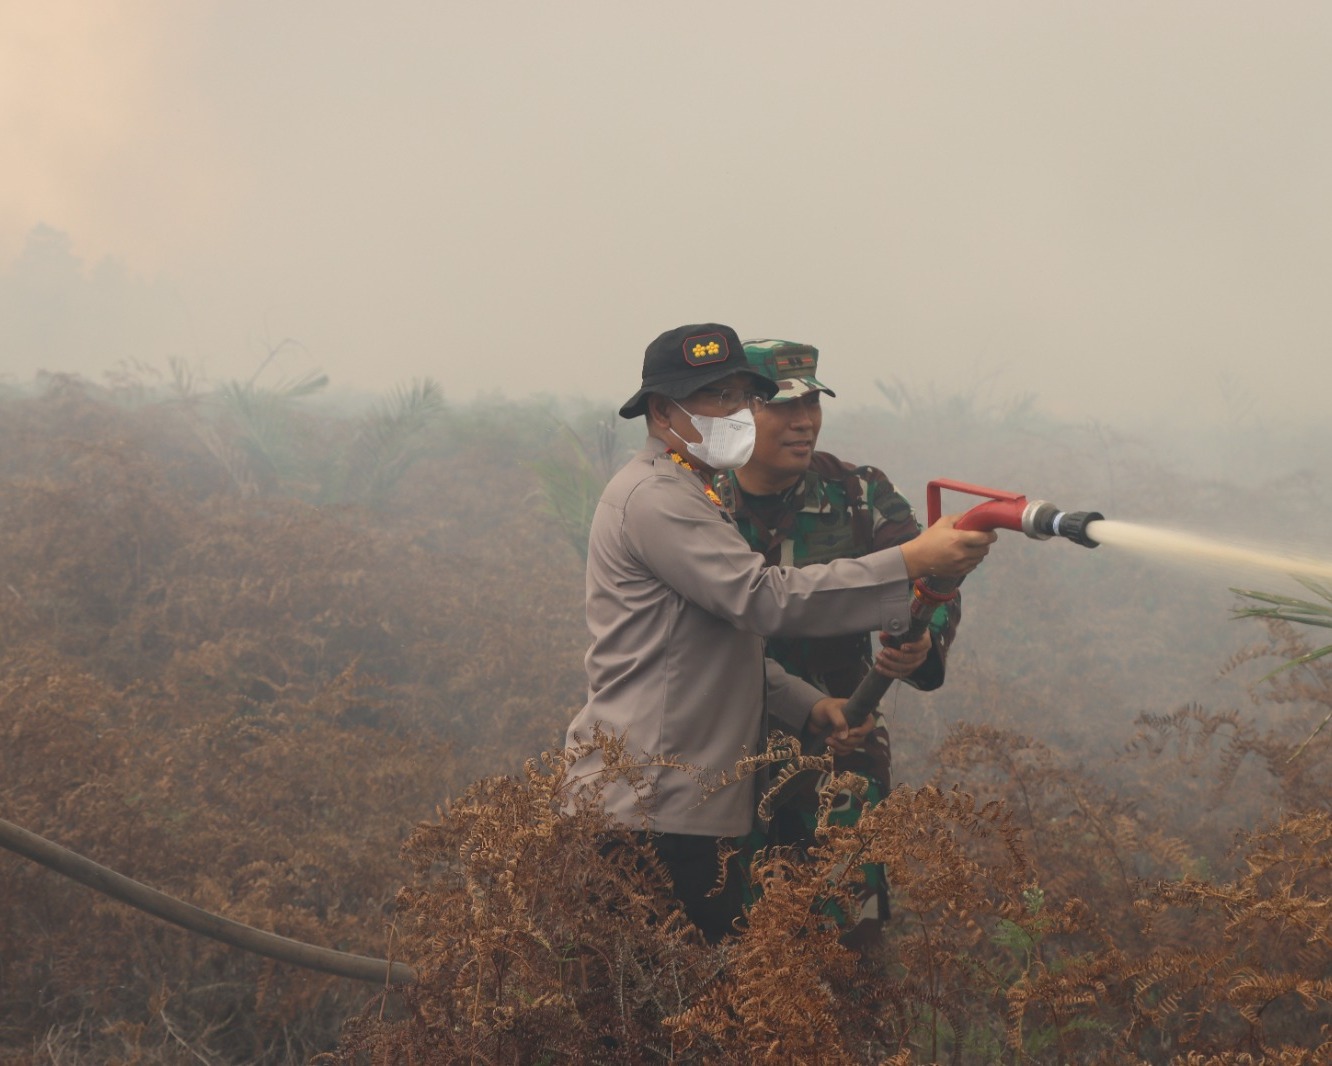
(0, 0, 1332, 422)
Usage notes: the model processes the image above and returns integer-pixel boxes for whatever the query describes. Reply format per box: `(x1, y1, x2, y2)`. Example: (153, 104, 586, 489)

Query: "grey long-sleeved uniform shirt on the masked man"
(567, 438, 911, 837)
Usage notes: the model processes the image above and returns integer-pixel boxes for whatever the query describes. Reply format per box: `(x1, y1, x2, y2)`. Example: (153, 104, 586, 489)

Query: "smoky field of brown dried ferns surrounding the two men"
(0, 366, 1332, 1066)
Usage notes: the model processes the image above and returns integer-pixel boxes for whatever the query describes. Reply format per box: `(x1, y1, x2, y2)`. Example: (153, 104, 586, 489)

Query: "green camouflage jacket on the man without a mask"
(715, 452, 962, 697)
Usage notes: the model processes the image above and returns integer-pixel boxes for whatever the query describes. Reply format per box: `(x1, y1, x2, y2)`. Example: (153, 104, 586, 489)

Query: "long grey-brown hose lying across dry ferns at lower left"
(0, 818, 416, 985)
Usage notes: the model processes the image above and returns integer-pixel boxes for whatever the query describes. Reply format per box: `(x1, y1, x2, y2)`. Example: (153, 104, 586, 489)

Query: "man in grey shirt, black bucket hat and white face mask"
(567, 322, 995, 941)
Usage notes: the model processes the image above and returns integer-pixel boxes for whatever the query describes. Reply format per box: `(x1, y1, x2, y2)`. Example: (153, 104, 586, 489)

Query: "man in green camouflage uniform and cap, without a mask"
(715, 340, 959, 949)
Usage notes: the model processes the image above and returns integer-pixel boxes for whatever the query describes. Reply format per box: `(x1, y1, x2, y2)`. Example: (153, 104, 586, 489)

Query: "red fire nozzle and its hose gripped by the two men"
(842, 478, 1106, 729)
